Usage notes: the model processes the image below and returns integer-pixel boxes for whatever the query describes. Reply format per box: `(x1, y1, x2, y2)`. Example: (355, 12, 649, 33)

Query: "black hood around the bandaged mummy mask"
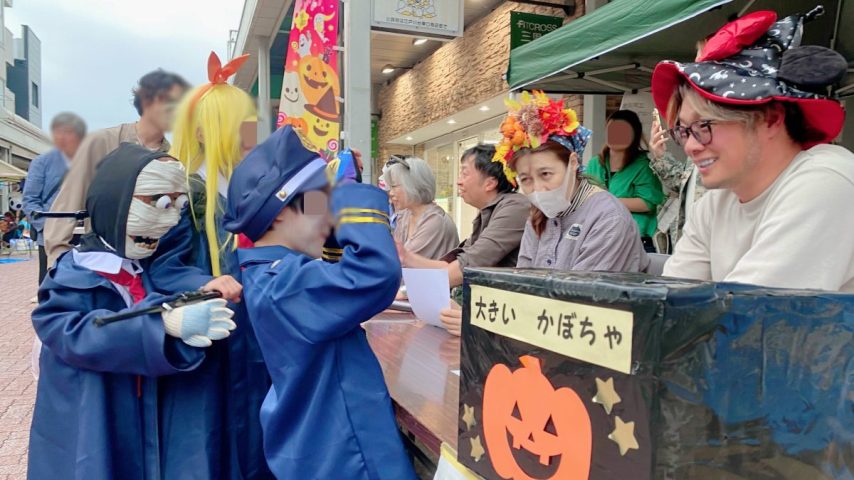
(78, 143, 169, 257)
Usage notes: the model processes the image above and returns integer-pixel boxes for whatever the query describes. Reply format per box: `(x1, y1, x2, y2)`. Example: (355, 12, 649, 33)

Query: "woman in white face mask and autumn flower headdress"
(496, 92, 649, 272)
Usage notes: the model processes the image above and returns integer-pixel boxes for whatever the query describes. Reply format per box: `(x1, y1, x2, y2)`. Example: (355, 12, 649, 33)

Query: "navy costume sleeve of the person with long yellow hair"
(148, 208, 213, 294)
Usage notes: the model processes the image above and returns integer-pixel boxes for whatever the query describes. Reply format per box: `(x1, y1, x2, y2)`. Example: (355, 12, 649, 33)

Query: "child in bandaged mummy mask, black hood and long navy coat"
(28, 144, 235, 480)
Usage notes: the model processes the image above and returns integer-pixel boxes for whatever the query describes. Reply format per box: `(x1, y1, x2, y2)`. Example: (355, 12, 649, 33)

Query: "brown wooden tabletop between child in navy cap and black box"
(365, 310, 460, 457)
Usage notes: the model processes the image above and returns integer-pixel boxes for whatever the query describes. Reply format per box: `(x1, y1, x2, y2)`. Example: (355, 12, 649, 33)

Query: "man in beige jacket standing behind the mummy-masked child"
(44, 70, 189, 266)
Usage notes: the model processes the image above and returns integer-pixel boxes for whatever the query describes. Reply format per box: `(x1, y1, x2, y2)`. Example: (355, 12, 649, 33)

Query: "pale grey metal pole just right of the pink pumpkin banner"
(342, 0, 373, 183)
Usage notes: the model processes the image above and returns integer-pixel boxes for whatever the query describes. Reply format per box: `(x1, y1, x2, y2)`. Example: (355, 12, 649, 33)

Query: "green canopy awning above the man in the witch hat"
(508, 0, 854, 95)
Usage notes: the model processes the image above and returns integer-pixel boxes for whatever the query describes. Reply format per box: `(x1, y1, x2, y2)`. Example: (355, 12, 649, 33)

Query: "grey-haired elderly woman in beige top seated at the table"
(388, 157, 460, 260)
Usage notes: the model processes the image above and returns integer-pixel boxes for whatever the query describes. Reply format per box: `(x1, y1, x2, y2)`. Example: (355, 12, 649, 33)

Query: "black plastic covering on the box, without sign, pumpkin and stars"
(458, 269, 854, 480)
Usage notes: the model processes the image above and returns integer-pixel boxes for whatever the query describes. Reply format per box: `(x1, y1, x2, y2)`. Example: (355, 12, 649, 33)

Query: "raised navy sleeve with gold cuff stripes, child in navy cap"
(263, 184, 401, 343)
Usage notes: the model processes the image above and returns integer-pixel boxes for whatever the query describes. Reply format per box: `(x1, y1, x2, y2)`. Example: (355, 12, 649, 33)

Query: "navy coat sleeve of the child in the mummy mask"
(33, 266, 204, 376)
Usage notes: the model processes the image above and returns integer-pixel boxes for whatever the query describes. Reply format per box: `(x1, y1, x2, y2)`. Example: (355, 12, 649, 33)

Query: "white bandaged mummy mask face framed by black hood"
(125, 158, 189, 260)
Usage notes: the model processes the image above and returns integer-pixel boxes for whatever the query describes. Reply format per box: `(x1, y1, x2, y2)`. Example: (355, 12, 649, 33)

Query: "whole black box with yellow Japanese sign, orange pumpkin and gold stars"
(457, 269, 854, 480)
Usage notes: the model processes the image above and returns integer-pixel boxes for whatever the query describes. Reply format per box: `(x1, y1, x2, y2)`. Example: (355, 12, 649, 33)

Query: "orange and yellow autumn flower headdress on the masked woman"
(492, 90, 592, 185)
